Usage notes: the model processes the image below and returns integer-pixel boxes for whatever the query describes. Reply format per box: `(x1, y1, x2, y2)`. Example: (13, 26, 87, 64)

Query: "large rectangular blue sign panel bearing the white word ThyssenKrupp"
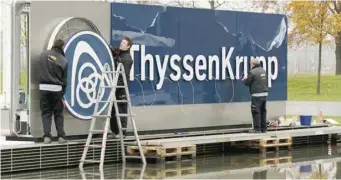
(111, 3, 287, 106)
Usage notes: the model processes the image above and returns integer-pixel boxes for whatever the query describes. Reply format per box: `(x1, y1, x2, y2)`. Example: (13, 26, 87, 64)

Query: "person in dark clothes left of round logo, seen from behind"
(39, 39, 67, 144)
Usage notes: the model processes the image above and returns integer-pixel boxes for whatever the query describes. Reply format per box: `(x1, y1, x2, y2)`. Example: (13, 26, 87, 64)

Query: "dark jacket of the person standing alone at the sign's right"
(243, 65, 268, 96)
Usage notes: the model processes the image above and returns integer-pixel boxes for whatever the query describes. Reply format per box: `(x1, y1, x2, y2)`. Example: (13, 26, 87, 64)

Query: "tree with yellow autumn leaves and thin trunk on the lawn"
(287, 1, 337, 94)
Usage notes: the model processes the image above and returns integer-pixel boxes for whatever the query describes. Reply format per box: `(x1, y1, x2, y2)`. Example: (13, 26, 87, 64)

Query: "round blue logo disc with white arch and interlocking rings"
(64, 31, 115, 120)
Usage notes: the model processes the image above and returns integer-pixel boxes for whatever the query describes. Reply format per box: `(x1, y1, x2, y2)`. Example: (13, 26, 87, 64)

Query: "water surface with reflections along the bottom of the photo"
(1, 146, 341, 179)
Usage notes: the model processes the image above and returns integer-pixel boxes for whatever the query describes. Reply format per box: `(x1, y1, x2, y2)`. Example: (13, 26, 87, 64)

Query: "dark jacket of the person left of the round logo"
(39, 48, 68, 95)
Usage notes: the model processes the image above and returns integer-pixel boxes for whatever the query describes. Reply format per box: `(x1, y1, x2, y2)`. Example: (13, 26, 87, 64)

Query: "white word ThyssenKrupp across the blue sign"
(130, 45, 278, 90)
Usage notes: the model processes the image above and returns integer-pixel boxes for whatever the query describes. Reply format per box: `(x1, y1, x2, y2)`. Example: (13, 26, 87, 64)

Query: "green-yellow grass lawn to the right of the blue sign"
(288, 74, 341, 101)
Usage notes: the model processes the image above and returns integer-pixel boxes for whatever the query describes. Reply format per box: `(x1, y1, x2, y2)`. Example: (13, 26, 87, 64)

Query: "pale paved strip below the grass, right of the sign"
(287, 101, 341, 116)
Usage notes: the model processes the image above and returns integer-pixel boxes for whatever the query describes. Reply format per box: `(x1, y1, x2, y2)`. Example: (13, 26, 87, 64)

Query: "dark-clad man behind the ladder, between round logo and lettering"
(110, 37, 133, 138)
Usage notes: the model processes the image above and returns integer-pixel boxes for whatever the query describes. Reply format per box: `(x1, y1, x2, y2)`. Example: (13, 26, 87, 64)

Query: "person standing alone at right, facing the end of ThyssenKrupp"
(243, 58, 268, 133)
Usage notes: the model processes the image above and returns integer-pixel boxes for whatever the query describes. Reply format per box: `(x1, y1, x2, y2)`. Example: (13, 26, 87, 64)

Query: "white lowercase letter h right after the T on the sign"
(141, 45, 154, 81)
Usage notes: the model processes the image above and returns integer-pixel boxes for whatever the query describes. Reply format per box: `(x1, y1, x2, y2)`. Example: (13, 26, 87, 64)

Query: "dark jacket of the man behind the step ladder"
(113, 48, 133, 85)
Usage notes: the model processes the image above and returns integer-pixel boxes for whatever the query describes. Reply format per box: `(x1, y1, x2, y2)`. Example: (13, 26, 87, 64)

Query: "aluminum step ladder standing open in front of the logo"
(79, 63, 146, 170)
